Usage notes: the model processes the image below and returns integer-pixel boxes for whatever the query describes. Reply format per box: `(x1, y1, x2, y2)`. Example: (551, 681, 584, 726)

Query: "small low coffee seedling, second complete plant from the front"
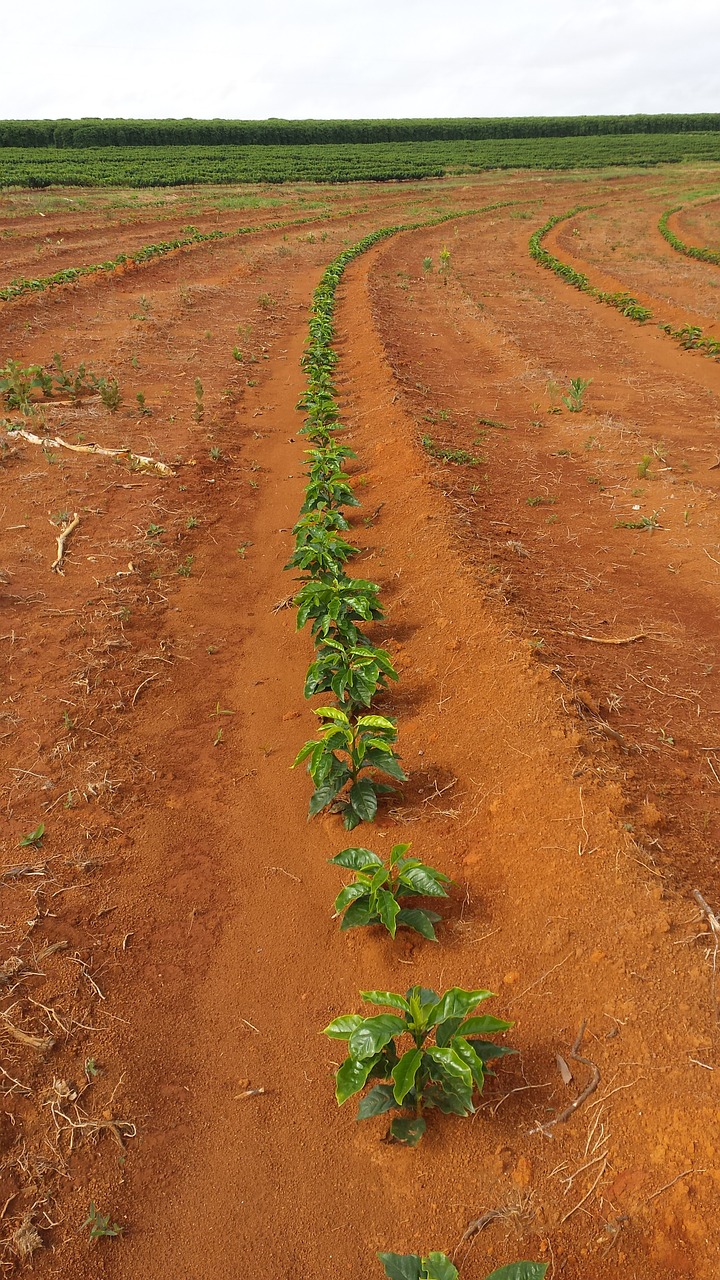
(329, 845, 450, 942)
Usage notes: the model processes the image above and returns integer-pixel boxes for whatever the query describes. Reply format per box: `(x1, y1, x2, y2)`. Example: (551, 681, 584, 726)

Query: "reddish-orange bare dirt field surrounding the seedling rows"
(0, 165, 720, 1280)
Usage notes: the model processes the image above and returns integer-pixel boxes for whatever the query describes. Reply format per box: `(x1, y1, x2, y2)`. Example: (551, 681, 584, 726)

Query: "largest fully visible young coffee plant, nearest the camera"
(324, 987, 514, 1147)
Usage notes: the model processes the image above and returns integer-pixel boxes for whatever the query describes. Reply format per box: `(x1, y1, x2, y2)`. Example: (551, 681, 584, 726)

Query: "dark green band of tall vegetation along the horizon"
(0, 113, 720, 148)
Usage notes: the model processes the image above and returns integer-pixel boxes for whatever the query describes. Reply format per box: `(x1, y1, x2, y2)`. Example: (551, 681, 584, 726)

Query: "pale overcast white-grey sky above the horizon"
(0, 0, 720, 119)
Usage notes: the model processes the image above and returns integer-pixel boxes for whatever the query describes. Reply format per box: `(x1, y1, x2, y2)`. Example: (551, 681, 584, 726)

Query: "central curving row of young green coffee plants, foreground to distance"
(286, 206, 544, 1280)
